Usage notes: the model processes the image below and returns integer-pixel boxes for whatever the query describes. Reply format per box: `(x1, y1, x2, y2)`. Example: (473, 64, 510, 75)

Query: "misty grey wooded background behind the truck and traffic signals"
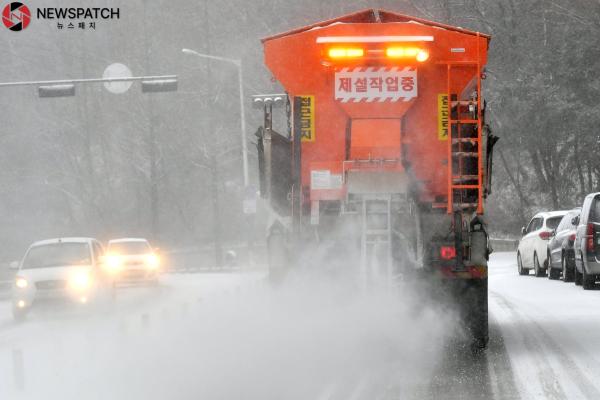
(0, 0, 600, 260)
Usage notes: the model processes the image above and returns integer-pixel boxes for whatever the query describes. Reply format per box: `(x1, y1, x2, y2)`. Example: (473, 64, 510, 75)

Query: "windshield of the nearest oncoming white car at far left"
(22, 243, 92, 269)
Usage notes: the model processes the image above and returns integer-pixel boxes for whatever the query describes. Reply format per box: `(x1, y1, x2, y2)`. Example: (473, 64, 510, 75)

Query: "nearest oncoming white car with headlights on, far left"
(12, 237, 110, 320)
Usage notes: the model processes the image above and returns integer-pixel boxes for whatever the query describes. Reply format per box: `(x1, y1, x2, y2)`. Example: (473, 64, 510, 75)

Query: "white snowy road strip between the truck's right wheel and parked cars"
(489, 253, 600, 399)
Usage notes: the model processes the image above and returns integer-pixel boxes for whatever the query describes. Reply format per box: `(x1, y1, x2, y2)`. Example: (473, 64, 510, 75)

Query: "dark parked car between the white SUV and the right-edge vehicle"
(547, 208, 581, 282)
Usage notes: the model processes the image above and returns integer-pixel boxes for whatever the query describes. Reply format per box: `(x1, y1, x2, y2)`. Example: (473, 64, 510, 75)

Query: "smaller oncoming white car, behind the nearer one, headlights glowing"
(105, 238, 160, 283)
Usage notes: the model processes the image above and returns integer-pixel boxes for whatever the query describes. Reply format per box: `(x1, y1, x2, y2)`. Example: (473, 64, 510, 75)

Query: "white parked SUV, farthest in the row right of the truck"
(517, 210, 569, 276)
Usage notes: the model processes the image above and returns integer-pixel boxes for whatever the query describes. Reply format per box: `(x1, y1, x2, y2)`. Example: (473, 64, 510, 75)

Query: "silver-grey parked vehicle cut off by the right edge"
(573, 192, 600, 290)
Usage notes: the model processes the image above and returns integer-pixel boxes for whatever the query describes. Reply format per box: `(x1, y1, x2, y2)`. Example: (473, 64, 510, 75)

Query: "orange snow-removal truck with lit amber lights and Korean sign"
(254, 9, 497, 347)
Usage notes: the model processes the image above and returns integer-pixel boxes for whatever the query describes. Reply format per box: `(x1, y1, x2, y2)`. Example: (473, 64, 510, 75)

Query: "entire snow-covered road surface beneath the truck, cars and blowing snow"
(0, 253, 600, 400)
